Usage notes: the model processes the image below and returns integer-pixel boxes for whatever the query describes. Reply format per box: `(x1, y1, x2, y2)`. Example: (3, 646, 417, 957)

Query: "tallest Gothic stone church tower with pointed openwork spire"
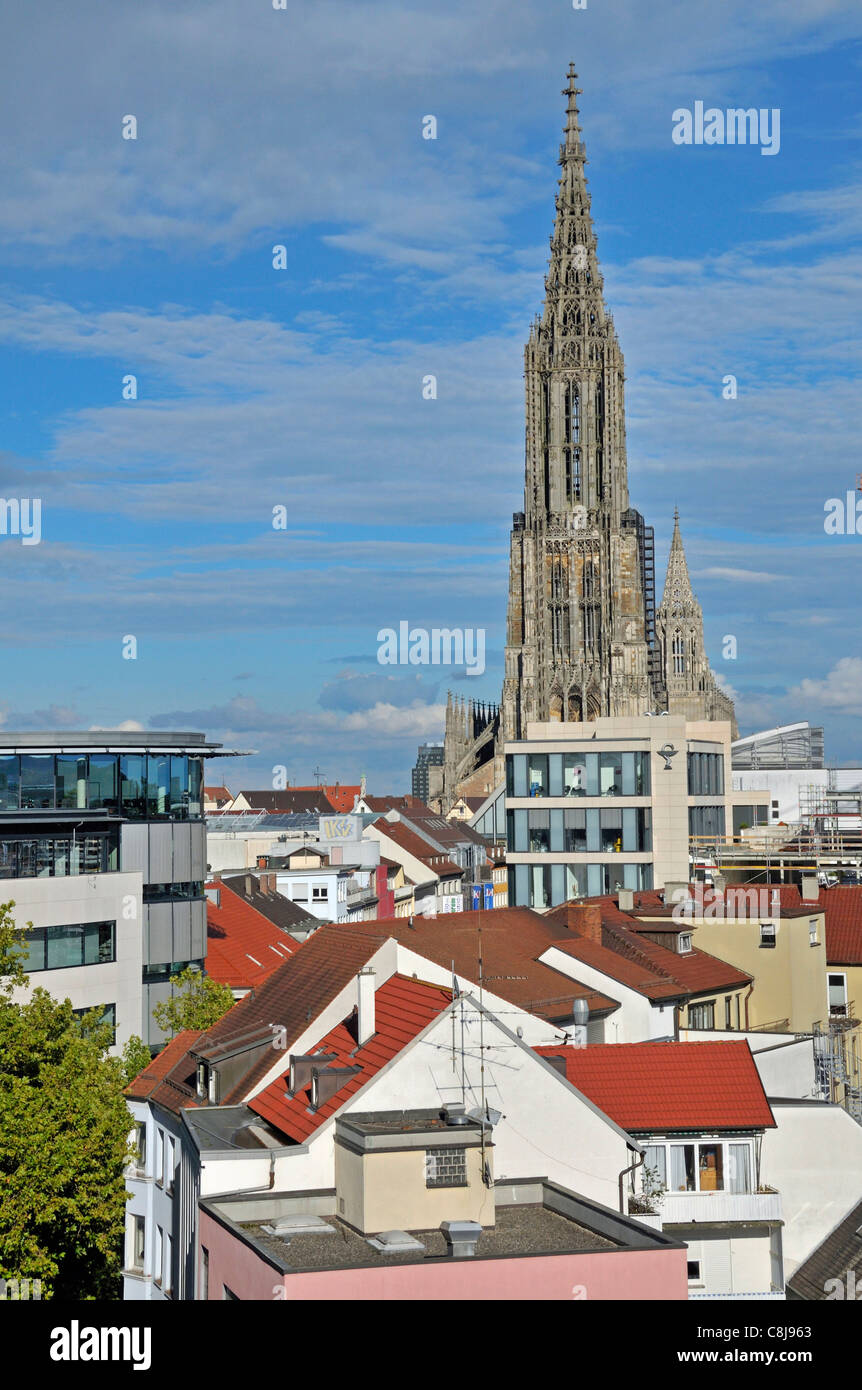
(501, 65, 652, 739)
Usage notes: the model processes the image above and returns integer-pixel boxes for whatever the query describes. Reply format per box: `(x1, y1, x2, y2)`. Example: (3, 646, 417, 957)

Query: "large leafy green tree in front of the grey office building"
(0, 904, 132, 1300)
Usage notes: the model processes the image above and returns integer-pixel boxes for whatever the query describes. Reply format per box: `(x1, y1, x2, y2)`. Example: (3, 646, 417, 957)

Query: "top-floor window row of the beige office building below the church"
(506, 752, 651, 796)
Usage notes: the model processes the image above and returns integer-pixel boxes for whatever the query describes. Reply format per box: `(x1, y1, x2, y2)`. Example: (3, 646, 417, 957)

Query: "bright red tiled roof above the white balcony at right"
(535, 1043, 776, 1134)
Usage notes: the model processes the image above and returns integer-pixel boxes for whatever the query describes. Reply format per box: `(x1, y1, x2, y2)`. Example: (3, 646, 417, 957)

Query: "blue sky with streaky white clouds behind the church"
(0, 0, 862, 791)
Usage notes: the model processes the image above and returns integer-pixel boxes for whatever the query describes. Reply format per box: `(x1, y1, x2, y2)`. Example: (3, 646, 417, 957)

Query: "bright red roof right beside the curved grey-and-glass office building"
(206, 883, 298, 990)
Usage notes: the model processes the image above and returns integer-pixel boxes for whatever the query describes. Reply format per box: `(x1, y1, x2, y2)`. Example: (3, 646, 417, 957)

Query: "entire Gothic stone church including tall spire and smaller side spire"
(442, 64, 735, 809)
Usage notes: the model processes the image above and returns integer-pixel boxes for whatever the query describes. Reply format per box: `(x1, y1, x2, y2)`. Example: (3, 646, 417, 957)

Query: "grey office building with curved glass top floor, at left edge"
(0, 730, 239, 1045)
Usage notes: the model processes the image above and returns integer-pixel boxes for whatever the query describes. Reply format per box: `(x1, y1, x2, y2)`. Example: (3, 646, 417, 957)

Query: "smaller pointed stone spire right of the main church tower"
(655, 512, 740, 738)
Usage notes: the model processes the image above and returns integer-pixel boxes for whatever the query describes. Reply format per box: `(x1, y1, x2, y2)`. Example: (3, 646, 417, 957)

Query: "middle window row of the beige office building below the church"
(506, 806, 652, 855)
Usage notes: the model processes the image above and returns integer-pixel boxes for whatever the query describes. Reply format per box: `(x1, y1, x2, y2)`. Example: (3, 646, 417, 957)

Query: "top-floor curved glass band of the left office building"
(0, 753, 203, 820)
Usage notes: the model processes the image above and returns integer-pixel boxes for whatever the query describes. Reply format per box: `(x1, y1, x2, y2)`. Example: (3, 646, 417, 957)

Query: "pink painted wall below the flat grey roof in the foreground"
(200, 1212, 688, 1302)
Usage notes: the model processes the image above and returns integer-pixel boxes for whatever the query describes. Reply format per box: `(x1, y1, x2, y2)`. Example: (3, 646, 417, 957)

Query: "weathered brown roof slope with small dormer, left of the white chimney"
(145, 926, 381, 1111)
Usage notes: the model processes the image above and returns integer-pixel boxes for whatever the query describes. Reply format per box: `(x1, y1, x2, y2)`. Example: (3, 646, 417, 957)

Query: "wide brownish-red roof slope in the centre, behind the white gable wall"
(328, 908, 619, 1020)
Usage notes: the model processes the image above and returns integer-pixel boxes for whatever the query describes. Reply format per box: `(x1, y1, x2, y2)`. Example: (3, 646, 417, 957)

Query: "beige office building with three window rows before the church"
(505, 714, 765, 909)
